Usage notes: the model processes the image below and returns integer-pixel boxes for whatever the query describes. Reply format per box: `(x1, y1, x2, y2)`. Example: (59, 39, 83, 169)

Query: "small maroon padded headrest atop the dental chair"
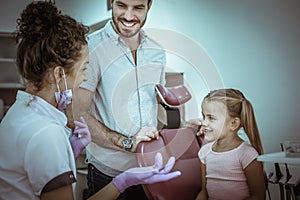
(155, 85, 192, 107)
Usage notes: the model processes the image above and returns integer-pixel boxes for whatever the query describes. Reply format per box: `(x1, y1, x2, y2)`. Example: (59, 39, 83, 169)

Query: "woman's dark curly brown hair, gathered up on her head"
(16, 1, 89, 90)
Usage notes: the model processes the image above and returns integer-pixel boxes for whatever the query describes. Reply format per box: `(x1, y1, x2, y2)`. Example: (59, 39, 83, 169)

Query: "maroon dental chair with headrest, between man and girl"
(136, 85, 202, 200)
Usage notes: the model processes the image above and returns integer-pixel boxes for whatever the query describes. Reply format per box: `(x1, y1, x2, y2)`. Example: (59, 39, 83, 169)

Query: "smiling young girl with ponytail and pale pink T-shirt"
(196, 89, 265, 200)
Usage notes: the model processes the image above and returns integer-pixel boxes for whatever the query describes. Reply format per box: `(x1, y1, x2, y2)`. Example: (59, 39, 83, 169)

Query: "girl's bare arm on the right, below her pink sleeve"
(244, 160, 266, 200)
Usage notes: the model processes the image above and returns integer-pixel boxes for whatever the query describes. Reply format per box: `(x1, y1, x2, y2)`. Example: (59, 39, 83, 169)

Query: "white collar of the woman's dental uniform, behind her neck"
(16, 90, 67, 127)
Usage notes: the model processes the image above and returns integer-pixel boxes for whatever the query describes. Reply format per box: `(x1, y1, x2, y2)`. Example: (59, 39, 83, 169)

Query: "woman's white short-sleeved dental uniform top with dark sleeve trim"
(0, 91, 76, 199)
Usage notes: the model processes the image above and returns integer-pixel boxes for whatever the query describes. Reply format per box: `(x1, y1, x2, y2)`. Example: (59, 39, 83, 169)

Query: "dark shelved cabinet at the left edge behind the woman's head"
(0, 32, 24, 118)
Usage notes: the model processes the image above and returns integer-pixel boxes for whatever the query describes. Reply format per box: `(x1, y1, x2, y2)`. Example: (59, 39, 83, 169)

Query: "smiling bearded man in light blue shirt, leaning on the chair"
(72, 0, 166, 199)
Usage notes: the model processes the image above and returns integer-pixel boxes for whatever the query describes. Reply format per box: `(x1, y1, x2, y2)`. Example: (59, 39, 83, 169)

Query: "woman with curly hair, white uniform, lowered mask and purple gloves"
(0, 1, 180, 200)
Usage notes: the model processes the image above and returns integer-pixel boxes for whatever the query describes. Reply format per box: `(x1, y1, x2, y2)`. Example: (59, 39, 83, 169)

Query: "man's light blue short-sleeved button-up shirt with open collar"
(81, 21, 166, 175)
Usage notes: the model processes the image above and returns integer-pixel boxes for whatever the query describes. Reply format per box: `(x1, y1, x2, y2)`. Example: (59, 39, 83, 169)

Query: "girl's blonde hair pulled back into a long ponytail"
(203, 89, 263, 155)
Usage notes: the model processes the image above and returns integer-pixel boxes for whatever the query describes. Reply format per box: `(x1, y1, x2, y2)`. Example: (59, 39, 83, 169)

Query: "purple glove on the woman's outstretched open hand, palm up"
(112, 153, 181, 193)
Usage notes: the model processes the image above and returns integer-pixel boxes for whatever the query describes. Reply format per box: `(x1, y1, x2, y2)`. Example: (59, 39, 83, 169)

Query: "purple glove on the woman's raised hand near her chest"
(70, 117, 92, 159)
